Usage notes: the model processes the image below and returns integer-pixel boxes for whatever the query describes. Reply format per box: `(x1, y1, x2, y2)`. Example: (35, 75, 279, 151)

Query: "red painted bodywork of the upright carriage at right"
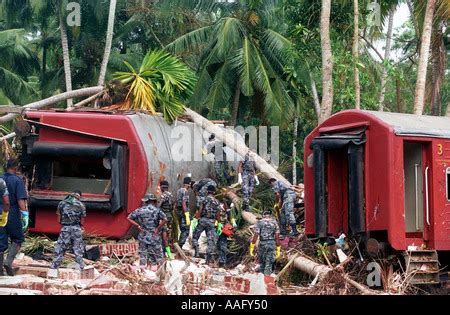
(304, 110, 450, 250)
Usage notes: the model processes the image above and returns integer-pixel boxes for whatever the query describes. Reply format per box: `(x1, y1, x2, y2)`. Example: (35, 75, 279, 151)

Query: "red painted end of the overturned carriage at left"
(26, 111, 148, 238)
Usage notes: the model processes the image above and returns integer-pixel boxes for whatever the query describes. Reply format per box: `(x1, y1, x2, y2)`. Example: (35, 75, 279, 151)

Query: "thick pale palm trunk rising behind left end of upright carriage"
(319, 0, 333, 124)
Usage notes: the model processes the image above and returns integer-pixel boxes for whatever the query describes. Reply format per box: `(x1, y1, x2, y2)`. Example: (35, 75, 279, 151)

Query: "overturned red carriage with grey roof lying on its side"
(20, 110, 236, 238)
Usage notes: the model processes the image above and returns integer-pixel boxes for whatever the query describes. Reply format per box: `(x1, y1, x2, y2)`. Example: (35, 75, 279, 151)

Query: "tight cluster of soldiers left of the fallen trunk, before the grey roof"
(128, 177, 237, 270)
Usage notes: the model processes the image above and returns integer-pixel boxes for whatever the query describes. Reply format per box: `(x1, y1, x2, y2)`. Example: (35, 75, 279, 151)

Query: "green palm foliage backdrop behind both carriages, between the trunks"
(0, 0, 450, 188)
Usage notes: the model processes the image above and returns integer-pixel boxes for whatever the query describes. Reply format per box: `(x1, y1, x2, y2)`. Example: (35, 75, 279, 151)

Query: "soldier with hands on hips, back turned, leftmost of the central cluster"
(128, 194, 167, 271)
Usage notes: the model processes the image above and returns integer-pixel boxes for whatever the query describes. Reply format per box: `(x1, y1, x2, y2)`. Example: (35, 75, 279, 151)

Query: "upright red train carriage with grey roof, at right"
(304, 110, 450, 251)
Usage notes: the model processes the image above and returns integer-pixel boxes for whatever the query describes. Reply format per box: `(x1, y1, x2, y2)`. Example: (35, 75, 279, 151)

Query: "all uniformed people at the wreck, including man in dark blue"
(0, 146, 298, 275)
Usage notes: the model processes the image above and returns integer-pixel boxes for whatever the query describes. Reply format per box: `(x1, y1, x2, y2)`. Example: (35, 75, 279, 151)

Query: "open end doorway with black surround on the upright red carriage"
(311, 126, 366, 238)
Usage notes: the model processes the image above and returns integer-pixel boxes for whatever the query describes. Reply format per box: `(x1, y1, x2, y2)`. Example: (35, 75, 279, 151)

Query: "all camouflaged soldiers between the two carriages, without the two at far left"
(125, 148, 299, 275)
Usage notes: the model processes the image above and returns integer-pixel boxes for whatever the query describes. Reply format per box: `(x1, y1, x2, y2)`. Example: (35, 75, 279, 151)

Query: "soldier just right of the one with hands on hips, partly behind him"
(158, 180, 176, 258)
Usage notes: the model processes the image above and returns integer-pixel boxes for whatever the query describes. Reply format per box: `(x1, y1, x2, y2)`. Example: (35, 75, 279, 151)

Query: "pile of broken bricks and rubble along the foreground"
(0, 238, 280, 295)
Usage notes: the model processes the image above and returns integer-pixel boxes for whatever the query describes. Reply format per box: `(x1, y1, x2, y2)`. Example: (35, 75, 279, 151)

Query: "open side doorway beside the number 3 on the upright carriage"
(403, 141, 431, 240)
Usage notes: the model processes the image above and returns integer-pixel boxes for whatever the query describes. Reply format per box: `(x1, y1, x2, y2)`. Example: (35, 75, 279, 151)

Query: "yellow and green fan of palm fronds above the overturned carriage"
(114, 50, 196, 123)
